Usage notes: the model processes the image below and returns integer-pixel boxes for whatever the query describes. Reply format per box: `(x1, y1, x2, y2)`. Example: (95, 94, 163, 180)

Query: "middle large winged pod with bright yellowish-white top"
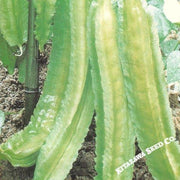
(89, 0, 135, 180)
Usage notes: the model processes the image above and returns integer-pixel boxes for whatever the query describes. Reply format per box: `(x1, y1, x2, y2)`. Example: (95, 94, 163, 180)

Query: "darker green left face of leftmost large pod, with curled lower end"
(0, 0, 71, 166)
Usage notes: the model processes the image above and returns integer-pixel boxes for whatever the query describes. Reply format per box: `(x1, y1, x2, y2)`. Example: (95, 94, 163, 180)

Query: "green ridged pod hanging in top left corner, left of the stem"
(0, 0, 28, 47)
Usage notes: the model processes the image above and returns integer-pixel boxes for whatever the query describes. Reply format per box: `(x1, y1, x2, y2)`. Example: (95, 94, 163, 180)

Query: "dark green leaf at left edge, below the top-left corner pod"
(0, 33, 16, 74)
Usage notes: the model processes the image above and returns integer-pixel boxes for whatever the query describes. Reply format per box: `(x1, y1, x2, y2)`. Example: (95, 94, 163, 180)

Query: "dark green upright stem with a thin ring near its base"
(25, 0, 39, 124)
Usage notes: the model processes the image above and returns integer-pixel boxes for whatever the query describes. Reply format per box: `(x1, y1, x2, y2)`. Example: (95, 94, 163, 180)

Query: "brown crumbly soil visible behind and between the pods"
(0, 47, 180, 180)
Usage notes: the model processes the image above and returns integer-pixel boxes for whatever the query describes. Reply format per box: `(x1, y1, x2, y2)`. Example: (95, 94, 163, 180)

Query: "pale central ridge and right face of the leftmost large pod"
(34, 0, 90, 180)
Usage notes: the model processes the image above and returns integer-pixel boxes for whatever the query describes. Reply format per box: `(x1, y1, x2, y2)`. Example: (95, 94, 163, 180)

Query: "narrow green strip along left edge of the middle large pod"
(87, 1, 105, 178)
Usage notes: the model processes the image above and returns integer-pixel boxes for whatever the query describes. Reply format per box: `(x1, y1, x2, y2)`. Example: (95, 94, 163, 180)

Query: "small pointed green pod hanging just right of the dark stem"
(34, 0, 56, 51)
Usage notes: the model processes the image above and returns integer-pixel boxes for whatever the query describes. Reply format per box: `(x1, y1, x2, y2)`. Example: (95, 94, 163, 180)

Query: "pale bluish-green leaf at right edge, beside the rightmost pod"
(167, 51, 180, 83)
